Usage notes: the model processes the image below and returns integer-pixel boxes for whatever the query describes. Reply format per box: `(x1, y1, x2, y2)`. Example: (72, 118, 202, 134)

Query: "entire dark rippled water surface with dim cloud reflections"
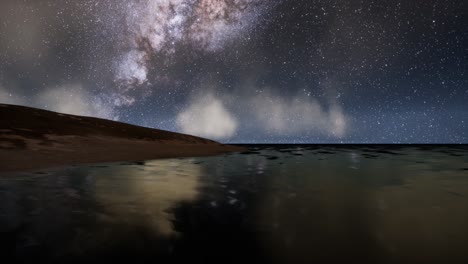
(0, 146, 468, 263)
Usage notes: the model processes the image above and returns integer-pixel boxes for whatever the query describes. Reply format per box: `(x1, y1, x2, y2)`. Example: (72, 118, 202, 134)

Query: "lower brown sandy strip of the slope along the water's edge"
(0, 138, 241, 174)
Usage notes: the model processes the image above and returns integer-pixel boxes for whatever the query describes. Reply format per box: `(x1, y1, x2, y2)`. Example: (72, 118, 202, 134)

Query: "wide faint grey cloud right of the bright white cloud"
(250, 92, 348, 138)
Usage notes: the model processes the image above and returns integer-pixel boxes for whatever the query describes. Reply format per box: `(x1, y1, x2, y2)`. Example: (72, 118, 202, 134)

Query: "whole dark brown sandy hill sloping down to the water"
(0, 104, 242, 172)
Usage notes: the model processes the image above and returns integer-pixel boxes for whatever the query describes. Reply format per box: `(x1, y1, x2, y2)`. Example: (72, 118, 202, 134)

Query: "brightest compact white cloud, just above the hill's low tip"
(176, 94, 238, 139)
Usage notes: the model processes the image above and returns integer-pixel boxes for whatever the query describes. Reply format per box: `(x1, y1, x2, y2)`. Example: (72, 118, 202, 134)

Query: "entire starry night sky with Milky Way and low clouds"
(0, 0, 468, 143)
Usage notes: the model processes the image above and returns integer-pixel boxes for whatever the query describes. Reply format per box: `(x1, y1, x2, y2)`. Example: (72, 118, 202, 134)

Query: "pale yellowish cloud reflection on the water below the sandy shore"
(94, 160, 202, 236)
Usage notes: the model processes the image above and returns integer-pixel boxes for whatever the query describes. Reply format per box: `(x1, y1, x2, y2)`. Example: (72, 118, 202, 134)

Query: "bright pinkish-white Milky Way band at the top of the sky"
(112, 0, 272, 100)
